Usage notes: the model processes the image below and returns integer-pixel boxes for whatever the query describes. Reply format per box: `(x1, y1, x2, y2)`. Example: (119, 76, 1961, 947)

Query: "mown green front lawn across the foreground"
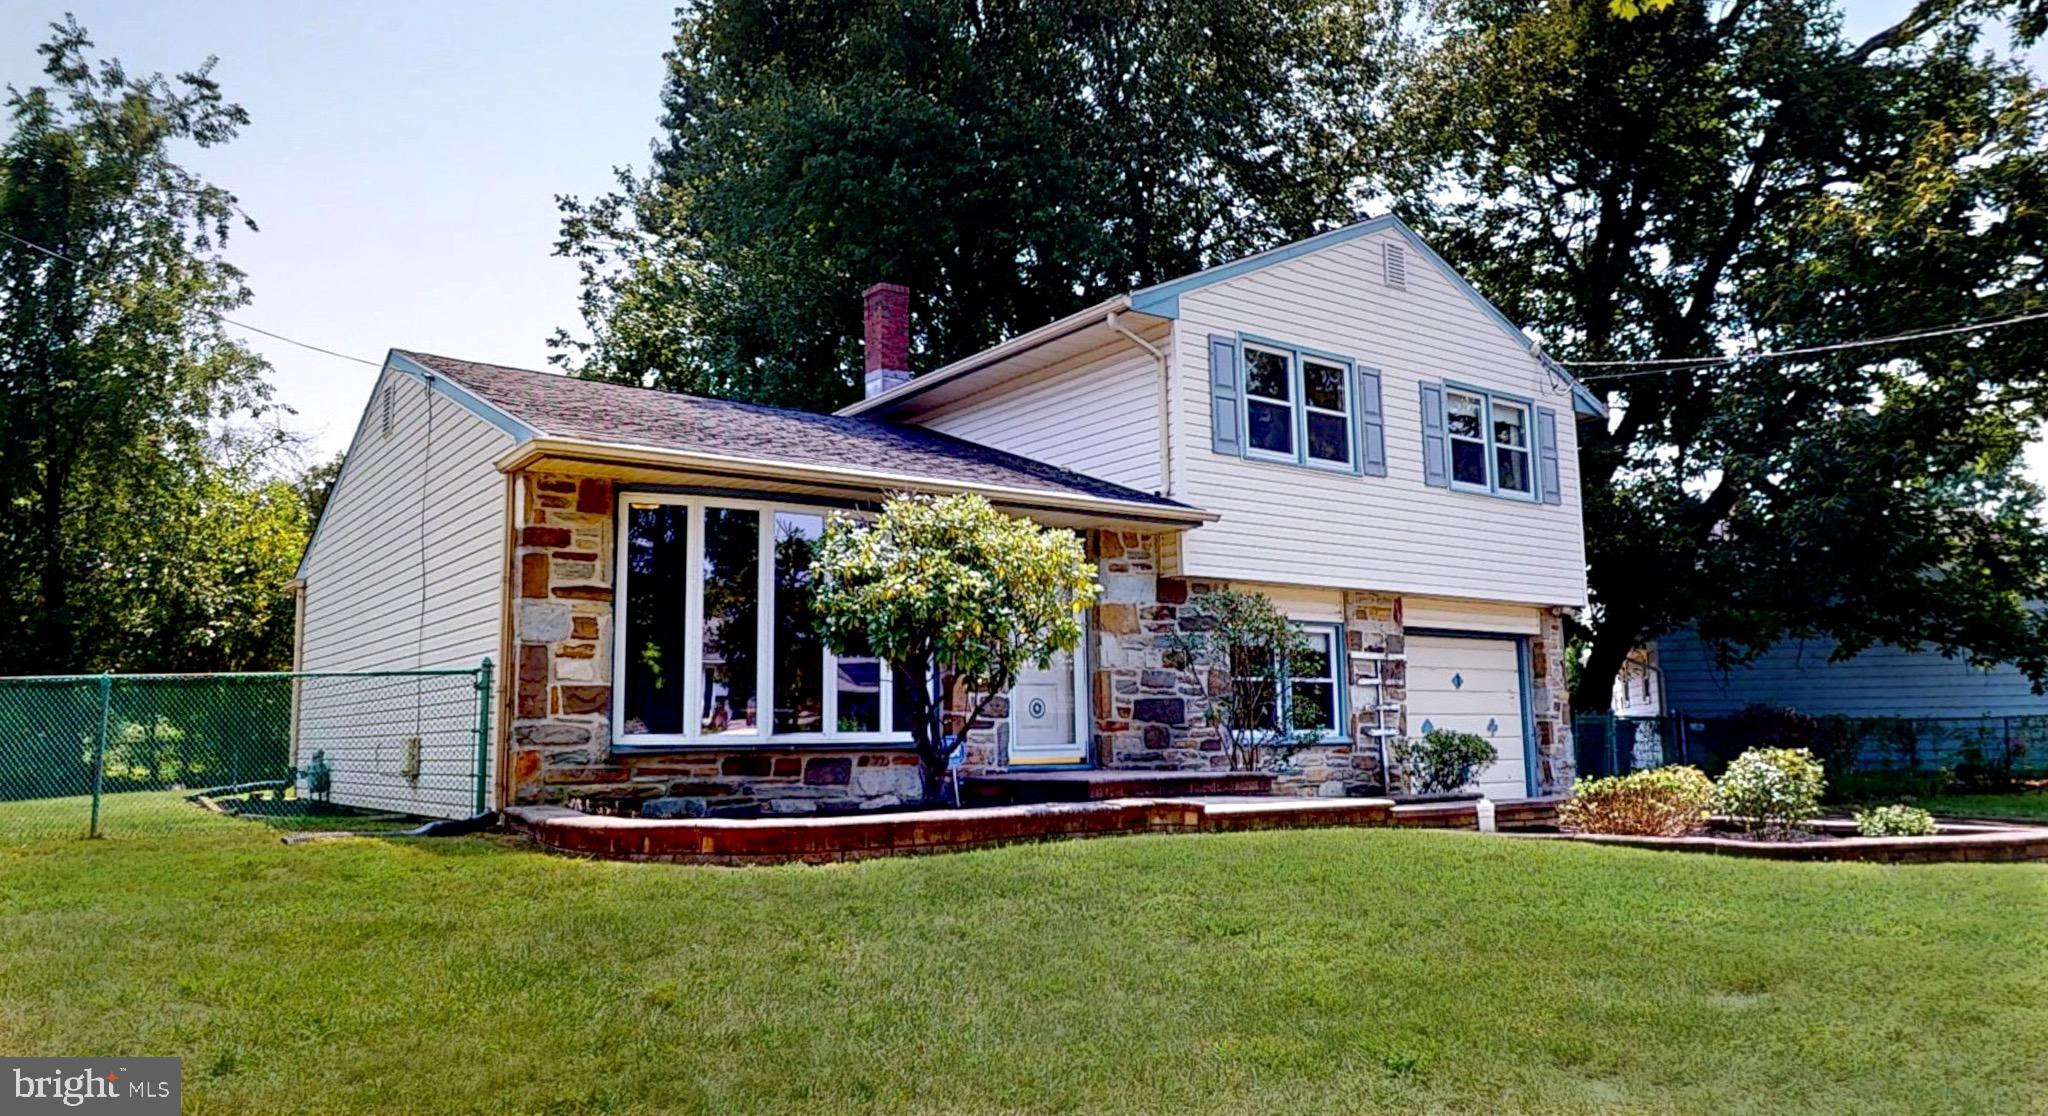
(0, 794, 2048, 1114)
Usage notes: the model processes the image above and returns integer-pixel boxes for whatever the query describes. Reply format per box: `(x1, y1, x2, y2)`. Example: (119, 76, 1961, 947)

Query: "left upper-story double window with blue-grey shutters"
(1219, 331, 1378, 473)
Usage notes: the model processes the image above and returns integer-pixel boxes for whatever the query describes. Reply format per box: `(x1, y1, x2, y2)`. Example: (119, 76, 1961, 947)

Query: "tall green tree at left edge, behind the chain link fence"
(0, 18, 268, 674)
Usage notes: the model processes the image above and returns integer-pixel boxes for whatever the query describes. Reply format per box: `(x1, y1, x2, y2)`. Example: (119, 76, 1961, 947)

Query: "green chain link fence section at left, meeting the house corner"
(0, 661, 492, 846)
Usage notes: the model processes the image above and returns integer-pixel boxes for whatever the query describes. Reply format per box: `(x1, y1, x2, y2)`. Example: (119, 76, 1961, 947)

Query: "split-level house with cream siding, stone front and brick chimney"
(299, 217, 1602, 813)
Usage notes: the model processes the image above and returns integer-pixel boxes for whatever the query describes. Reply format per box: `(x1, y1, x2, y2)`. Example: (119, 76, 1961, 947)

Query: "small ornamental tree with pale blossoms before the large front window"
(811, 496, 1100, 803)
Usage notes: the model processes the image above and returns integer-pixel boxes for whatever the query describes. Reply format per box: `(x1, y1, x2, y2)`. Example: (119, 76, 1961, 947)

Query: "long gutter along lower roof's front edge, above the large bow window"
(492, 436, 1219, 524)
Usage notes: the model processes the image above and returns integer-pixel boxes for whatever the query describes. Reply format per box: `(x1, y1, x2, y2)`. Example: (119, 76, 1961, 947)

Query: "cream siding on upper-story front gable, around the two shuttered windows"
(1174, 229, 1585, 606)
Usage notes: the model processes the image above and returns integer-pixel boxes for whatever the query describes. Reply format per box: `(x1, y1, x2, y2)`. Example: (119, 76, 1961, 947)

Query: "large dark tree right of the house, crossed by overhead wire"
(1382, 0, 2048, 709)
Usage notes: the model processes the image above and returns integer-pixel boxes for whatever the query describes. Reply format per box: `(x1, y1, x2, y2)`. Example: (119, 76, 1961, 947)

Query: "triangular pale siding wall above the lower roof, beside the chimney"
(909, 334, 1163, 491)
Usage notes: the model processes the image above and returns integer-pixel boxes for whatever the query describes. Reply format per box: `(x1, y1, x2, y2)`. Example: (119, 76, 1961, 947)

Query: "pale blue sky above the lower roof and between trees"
(0, 0, 2048, 483)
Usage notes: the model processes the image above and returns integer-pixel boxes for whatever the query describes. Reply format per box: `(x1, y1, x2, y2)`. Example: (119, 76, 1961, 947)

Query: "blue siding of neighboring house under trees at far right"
(1657, 633, 2048, 717)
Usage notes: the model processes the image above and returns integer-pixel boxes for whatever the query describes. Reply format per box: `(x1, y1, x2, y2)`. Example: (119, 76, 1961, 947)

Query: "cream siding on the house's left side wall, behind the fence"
(295, 369, 512, 817)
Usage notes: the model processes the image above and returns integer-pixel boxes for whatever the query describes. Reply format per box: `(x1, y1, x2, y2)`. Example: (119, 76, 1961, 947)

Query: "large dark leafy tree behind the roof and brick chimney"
(555, 0, 1376, 407)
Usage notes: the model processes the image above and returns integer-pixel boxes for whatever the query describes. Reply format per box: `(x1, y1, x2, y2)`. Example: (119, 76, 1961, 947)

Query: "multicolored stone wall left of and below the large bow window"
(510, 473, 925, 813)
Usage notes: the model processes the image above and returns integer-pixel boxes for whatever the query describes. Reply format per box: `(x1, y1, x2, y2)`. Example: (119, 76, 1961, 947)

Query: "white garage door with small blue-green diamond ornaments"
(1407, 635, 1530, 799)
